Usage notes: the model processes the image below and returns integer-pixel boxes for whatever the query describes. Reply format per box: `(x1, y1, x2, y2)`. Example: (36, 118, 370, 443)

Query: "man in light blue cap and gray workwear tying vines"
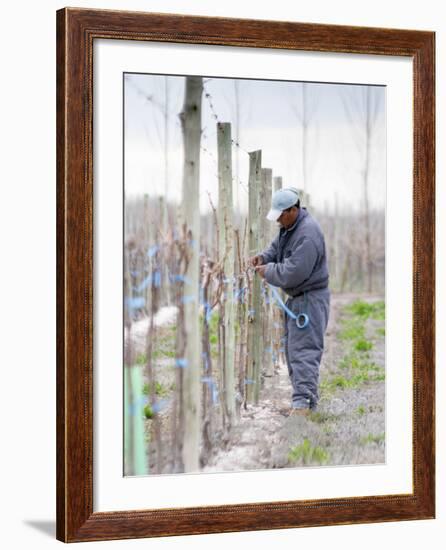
(250, 187, 330, 415)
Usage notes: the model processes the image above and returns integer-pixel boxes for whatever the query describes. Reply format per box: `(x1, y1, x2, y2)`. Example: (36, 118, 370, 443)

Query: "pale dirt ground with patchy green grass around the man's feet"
(127, 294, 385, 473)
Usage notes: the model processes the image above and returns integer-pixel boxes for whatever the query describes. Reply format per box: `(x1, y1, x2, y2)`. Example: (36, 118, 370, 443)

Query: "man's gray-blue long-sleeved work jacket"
(261, 207, 328, 296)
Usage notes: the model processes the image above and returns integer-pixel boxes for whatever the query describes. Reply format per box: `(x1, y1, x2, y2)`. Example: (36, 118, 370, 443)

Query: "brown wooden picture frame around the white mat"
(57, 8, 435, 542)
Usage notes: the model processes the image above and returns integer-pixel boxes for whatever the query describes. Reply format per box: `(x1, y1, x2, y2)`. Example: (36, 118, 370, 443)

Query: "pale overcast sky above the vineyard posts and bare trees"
(124, 74, 386, 217)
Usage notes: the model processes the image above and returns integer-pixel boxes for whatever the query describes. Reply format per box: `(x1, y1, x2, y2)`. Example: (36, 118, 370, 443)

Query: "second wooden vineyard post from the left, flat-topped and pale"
(217, 122, 235, 428)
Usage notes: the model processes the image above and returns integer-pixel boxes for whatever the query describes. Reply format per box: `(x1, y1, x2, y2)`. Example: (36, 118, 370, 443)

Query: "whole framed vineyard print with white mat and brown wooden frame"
(57, 8, 435, 542)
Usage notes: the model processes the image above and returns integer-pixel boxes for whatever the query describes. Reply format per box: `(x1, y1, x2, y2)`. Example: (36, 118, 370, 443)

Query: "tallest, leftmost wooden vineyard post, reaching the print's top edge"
(180, 77, 203, 472)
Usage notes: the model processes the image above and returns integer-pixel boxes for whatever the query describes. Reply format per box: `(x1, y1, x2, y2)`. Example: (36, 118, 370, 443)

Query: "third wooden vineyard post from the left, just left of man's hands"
(245, 151, 262, 403)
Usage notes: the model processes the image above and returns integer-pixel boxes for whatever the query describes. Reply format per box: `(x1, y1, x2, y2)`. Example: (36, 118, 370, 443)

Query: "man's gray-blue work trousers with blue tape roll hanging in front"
(284, 288, 330, 410)
